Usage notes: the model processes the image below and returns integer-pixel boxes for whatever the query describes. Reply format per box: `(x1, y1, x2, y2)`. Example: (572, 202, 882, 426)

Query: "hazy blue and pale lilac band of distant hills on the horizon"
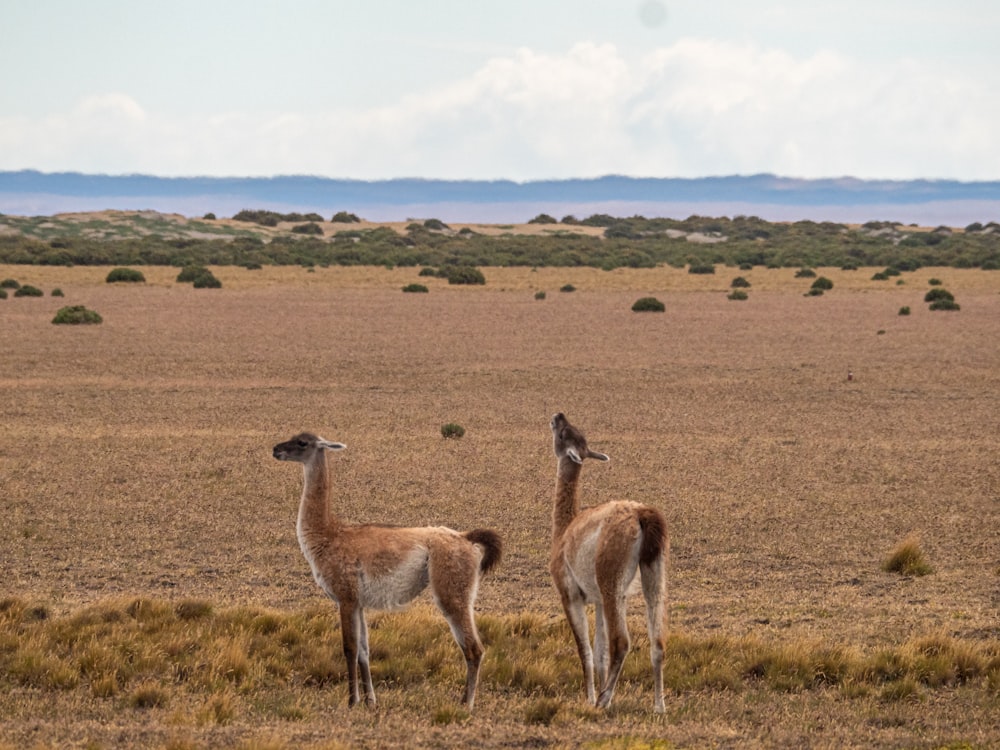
(0, 170, 1000, 226)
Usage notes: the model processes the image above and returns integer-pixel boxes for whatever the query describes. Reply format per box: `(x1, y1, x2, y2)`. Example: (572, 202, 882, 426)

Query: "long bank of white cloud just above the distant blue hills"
(0, 39, 1000, 179)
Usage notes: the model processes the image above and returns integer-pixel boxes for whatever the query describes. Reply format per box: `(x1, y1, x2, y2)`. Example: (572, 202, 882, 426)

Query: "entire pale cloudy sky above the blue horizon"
(0, 0, 1000, 181)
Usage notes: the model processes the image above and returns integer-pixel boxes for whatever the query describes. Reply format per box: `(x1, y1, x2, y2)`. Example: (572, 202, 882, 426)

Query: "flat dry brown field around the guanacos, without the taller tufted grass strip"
(0, 266, 1000, 748)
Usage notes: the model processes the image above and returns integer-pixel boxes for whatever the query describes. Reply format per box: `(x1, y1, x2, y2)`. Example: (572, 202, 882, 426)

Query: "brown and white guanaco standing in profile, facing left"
(273, 432, 503, 710)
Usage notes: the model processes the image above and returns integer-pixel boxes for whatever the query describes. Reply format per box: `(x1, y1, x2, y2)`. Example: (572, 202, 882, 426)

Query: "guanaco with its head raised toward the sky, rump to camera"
(549, 413, 669, 712)
